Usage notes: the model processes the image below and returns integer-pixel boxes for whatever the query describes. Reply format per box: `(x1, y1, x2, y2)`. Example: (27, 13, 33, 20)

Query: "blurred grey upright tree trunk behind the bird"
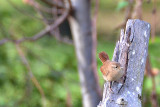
(69, 0, 101, 107)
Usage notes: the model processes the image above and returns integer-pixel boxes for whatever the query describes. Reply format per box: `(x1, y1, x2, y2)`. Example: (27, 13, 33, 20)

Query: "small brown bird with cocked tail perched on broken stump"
(99, 52, 125, 92)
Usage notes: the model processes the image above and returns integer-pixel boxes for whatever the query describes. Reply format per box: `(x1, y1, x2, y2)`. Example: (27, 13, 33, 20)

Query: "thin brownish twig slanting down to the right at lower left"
(15, 44, 46, 107)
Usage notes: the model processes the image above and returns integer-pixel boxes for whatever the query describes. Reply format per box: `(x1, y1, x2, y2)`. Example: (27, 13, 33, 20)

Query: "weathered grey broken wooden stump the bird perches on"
(98, 19, 150, 107)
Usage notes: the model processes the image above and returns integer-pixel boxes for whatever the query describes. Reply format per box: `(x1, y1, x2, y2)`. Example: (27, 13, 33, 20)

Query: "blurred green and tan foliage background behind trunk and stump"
(0, 0, 160, 107)
